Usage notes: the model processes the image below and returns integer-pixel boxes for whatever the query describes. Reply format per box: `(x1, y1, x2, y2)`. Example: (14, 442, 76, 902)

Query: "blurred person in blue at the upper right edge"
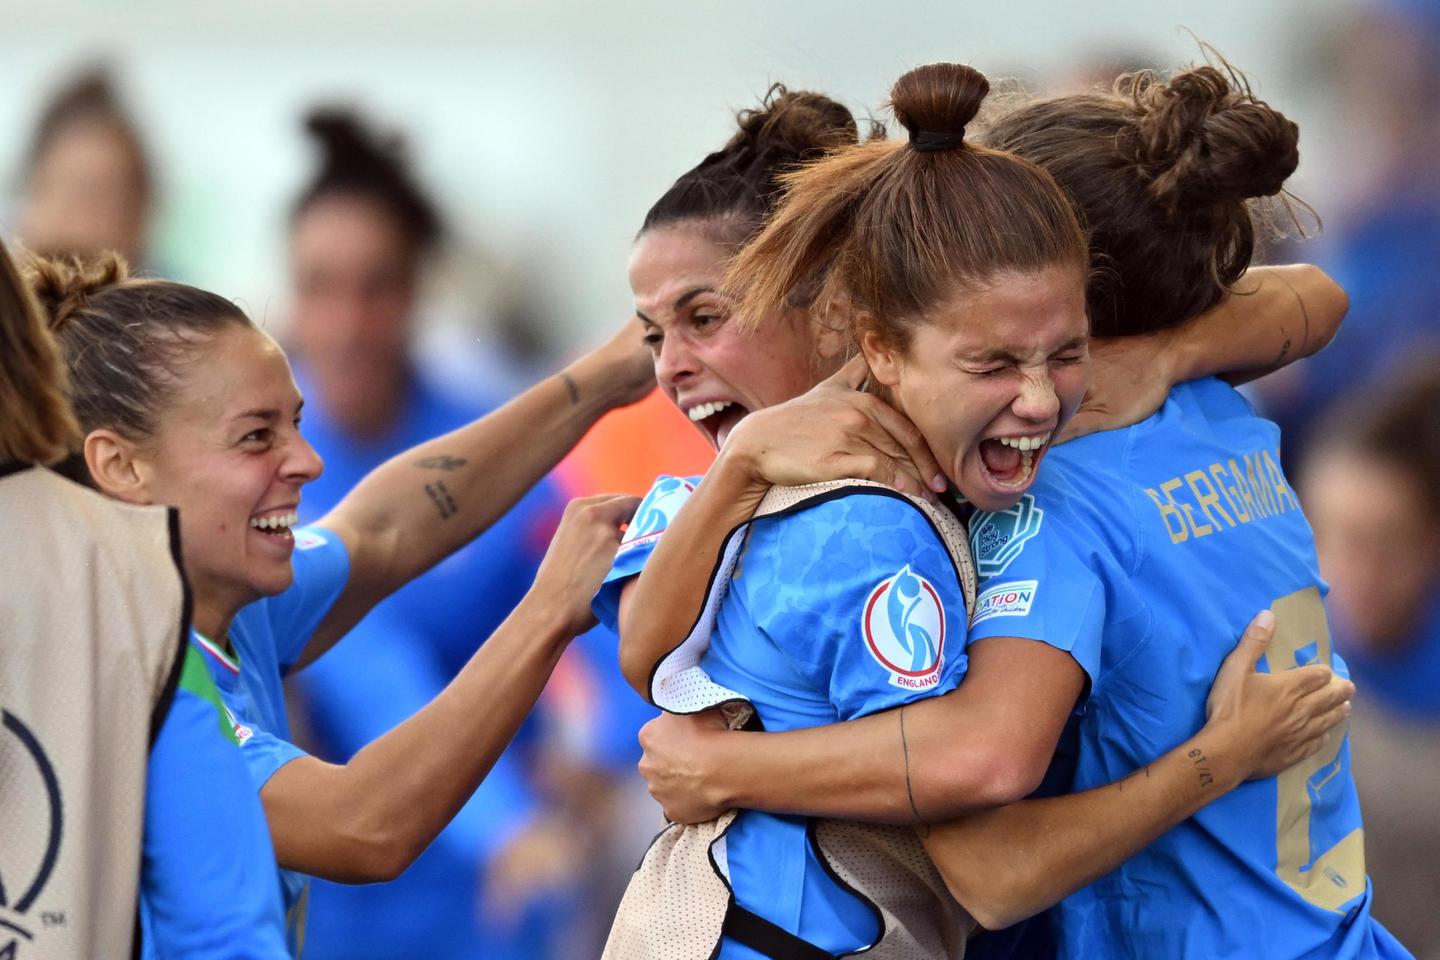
(1256, 0, 1440, 469)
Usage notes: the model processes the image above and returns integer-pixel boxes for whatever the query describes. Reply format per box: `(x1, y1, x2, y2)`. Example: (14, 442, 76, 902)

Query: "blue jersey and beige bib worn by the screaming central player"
(606, 482, 972, 960)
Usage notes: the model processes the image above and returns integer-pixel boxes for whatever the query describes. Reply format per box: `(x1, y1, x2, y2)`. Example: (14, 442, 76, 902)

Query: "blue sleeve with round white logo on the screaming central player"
(732, 492, 966, 720)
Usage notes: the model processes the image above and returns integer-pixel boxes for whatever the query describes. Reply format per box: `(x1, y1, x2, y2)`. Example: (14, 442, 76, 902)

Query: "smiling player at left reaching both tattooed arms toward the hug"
(32, 250, 652, 950)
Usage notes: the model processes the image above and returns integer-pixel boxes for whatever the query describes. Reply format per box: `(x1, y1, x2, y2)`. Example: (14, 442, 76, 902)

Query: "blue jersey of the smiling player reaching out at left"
(193, 527, 350, 954)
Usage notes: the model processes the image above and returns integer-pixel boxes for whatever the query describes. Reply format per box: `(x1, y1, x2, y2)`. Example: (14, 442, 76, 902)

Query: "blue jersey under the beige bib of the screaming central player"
(701, 488, 966, 959)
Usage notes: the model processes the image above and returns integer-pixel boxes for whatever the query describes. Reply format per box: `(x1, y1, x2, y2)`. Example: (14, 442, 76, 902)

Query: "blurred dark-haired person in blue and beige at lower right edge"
(1302, 362, 1440, 959)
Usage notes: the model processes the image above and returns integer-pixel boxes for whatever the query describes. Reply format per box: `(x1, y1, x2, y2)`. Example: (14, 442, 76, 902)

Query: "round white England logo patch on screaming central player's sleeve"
(864, 564, 945, 689)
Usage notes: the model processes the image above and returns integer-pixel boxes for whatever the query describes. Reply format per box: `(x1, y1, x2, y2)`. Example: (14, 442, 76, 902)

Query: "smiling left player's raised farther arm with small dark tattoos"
(309, 321, 655, 666)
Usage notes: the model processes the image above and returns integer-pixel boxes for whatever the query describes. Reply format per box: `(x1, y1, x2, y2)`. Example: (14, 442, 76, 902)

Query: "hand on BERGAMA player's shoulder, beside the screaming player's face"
(1057, 330, 1175, 443)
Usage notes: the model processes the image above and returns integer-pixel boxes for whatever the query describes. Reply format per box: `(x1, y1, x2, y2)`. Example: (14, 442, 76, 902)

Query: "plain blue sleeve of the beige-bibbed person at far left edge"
(141, 648, 289, 960)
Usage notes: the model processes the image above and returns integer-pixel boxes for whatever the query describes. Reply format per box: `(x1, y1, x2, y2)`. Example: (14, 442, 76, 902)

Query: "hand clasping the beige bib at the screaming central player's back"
(639, 710, 730, 823)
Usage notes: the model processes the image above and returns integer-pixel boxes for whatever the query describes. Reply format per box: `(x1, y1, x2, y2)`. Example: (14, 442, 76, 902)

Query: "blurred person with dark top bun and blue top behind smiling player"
(289, 108, 648, 959)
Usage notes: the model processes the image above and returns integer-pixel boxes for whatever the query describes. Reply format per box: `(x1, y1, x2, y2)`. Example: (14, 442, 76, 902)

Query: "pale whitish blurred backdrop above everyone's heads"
(0, 0, 1352, 343)
